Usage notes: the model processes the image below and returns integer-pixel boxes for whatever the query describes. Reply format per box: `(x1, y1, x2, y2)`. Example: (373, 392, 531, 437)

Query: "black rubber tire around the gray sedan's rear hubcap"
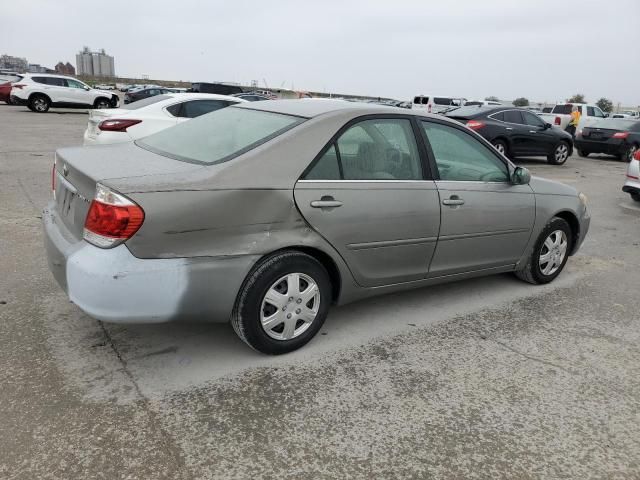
(231, 251, 331, 355)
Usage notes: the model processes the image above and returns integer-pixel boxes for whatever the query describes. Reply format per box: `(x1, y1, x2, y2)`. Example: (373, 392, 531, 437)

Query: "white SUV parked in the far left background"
(11, 73, 118, 113)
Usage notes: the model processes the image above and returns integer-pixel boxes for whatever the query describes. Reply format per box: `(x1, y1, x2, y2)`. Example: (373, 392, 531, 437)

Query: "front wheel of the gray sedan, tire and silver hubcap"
(515, 217, 572, 285)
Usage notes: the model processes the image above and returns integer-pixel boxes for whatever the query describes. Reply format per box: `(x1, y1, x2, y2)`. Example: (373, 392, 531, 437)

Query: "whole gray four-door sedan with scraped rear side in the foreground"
(43, 99, 590, 354)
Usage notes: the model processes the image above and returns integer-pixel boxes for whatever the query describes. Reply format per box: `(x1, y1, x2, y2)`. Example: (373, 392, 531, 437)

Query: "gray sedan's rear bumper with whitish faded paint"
(42, 202, 258, 323)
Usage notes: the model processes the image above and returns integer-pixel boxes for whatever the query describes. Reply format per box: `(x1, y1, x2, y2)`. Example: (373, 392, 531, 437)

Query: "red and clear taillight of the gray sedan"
(82, 184, 144, 248)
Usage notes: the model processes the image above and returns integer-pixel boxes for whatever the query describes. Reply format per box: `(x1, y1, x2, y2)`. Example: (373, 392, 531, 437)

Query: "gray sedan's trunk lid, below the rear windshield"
(53, 143, 203, 239)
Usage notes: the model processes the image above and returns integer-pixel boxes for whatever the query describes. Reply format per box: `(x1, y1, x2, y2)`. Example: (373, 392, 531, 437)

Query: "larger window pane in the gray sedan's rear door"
(337, 119, 422, 180)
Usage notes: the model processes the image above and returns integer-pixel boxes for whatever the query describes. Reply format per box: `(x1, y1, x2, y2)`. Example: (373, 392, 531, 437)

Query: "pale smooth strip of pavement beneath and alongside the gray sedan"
(92, 273, 576, 397)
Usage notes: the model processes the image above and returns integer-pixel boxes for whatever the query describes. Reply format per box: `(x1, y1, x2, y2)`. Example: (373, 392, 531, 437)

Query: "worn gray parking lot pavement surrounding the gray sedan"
(0, 105, 640, 479)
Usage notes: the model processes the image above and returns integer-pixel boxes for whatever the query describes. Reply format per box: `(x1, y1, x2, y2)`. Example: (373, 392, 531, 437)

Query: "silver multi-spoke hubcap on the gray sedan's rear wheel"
(260, 273, 320, 340)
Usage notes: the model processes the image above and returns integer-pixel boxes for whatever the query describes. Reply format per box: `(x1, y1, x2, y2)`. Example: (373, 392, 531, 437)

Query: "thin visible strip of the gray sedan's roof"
(235, 98, 428, 118)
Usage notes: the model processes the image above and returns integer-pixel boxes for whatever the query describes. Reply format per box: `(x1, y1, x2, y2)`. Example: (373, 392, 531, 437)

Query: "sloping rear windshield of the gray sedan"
(136, 107, 305, 165)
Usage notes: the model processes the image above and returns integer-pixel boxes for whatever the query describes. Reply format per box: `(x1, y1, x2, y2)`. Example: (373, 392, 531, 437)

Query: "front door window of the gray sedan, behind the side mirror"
(421, 121, 509, 182)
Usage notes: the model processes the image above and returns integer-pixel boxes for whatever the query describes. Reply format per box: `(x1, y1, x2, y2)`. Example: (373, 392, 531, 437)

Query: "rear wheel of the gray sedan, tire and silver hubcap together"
(231, 251, 331, 355)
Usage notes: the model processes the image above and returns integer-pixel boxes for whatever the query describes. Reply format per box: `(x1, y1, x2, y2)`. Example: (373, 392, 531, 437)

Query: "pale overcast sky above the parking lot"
(0, 0, 640, 106)
